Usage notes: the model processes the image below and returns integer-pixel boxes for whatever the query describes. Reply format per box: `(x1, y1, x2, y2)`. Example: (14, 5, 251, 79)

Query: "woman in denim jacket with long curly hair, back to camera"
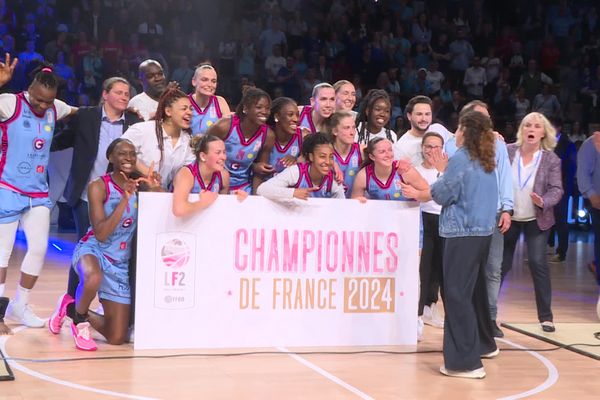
(431, 111, 498, 378)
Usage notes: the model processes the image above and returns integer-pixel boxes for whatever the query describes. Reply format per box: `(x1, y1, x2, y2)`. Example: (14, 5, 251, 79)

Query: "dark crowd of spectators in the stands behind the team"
(0, 0, 600, 142)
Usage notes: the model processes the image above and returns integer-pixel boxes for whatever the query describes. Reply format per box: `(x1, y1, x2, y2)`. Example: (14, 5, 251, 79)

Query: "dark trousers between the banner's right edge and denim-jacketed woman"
(419, 212, 444, 315)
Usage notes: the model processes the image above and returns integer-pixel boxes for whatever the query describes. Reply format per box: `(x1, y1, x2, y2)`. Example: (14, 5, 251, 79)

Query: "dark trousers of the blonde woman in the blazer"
(502, 220, 552, 322)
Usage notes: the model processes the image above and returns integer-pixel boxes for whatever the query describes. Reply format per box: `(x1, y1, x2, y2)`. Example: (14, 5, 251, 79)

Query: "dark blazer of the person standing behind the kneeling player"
(51, 106, 142, 207)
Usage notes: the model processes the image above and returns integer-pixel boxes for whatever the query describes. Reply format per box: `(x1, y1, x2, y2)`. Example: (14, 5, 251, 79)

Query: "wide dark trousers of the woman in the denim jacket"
(444, 235, 496, 371)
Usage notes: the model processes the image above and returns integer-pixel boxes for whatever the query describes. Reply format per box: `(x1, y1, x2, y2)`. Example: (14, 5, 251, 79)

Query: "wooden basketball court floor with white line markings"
(0, 230, 600, 400)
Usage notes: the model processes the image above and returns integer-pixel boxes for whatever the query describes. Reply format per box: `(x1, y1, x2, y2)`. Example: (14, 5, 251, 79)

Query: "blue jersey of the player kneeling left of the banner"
(77, 175, 137, 264)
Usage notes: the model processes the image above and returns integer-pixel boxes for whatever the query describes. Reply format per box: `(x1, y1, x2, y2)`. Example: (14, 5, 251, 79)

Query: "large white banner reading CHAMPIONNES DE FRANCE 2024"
(135, 193, 419, 349)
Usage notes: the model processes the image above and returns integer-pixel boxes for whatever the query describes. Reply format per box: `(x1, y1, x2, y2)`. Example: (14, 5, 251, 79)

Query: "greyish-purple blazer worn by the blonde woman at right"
(506, 143, 563, 231)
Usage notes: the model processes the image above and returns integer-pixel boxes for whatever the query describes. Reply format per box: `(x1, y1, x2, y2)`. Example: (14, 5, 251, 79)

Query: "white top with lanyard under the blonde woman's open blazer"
(512, 150, 542, 221)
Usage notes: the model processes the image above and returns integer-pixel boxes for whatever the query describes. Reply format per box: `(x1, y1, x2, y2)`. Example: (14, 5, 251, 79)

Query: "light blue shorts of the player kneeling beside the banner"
(72, 242, 131, 304)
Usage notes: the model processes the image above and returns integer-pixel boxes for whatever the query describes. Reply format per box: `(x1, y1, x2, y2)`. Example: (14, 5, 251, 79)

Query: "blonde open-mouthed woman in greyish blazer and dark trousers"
(502, 112, 563, 332)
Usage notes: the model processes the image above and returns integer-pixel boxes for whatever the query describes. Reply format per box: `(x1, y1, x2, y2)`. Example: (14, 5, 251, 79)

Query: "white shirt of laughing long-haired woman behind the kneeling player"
(122, 120, 196, 188)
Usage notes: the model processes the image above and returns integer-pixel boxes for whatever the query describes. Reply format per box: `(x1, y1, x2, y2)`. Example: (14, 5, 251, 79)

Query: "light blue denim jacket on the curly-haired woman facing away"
(431, 148, 498, 238)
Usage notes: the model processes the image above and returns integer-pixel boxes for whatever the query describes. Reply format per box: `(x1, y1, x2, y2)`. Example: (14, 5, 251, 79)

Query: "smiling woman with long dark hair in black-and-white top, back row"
(355, 89, 398, 144)
